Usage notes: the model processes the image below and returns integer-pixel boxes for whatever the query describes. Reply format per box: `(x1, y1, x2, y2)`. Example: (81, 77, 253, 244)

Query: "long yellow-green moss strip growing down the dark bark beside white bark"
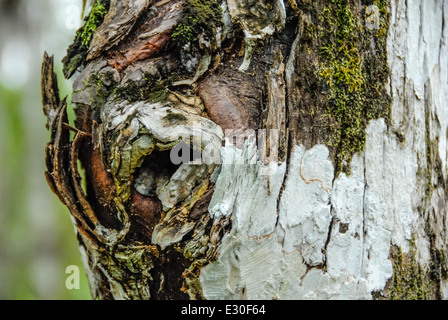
(318, 0, 390, 177)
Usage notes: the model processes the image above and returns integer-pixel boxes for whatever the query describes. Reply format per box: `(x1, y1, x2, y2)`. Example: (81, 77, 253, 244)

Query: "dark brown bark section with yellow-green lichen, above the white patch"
(290, 0, 391, 178)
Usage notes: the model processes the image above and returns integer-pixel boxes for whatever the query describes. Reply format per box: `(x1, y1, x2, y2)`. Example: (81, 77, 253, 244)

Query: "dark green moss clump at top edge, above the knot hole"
(171, 0, 222, 43)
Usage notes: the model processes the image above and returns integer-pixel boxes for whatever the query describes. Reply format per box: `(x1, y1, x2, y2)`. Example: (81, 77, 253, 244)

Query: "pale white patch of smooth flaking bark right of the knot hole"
(200, 0, 448, 299)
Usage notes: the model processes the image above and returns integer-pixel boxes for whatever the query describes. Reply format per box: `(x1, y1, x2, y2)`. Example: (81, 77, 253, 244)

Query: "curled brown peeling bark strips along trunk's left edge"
(42, 55, 136, 247)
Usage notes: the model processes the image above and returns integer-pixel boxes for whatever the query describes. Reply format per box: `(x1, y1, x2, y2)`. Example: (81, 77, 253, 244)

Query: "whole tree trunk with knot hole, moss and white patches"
(42, 0, 448, 299)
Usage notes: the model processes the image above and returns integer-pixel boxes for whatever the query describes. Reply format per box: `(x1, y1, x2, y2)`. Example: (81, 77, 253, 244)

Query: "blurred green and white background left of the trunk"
(0, 0, 91, 300)
